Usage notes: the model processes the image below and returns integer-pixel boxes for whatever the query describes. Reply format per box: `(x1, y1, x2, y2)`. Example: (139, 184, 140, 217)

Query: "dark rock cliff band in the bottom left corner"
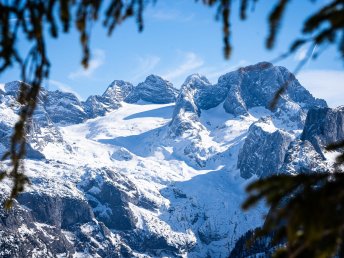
(0, 193, 132, 258)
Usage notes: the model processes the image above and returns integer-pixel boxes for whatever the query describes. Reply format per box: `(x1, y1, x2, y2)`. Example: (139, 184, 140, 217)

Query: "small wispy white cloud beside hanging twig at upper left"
(68, 49, 105, 79)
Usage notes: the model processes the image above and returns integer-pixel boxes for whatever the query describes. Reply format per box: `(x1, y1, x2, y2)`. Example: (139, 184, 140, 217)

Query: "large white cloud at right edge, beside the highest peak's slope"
(296, 70, 344, 107)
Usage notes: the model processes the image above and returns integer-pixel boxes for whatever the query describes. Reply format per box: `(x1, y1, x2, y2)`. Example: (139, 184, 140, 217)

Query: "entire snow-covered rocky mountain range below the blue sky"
(0, 62, 338, 257)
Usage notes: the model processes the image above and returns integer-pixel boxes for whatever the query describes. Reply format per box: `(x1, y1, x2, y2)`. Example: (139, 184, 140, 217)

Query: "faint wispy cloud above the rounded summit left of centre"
(131, 55, 160, 82)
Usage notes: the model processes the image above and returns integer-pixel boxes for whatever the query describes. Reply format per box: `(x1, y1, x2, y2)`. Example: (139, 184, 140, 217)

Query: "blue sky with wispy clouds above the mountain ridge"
(0, 0, 344, 106)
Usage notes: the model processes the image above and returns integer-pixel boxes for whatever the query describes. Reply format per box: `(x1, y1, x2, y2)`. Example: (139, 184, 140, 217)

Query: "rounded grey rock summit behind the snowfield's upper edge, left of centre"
(124, 75, 178, 104)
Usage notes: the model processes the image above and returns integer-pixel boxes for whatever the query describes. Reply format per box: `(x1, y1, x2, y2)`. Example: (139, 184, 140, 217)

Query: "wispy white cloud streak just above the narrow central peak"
(162, 52, 204, 83)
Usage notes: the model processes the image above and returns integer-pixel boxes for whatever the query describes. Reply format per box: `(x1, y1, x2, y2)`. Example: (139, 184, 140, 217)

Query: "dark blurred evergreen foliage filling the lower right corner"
(243, 141, 344, 257)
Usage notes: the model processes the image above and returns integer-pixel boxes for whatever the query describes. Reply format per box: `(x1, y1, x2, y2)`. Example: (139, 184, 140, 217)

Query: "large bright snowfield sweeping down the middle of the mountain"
(4, 103, 273, 257)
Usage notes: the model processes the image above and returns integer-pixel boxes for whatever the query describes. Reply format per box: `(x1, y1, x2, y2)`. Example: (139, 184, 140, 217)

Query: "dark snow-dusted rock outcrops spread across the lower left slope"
(0, 168, 163, 257)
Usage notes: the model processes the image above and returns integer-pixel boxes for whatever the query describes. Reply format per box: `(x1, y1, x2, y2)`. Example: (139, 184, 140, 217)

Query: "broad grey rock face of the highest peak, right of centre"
(218, 62, 326, 115)
